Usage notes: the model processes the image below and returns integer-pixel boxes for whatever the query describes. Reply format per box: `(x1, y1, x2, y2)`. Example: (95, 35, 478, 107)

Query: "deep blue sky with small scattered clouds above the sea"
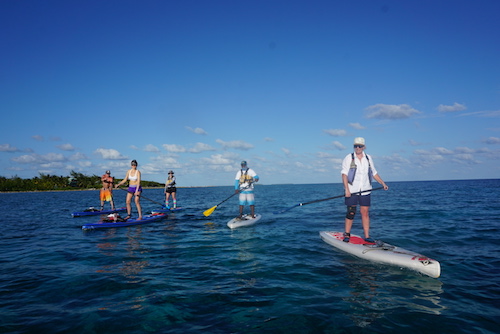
(0, 0, 500, 187)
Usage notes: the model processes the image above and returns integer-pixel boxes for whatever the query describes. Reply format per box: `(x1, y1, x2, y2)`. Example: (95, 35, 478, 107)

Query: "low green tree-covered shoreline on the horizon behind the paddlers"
(0, 171, 165, 192)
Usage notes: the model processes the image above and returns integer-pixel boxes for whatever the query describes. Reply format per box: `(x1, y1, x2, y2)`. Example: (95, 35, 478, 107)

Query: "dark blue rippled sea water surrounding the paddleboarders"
(0, 180, 500, 333)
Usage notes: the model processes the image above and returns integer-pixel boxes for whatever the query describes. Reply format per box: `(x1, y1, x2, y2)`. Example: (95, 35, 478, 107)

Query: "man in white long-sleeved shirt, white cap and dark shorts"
(341, 137, 389, 243)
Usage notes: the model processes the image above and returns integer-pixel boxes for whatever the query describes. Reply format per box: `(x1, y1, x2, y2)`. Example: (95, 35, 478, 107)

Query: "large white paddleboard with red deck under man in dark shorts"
(319, 231, 441, 278)
